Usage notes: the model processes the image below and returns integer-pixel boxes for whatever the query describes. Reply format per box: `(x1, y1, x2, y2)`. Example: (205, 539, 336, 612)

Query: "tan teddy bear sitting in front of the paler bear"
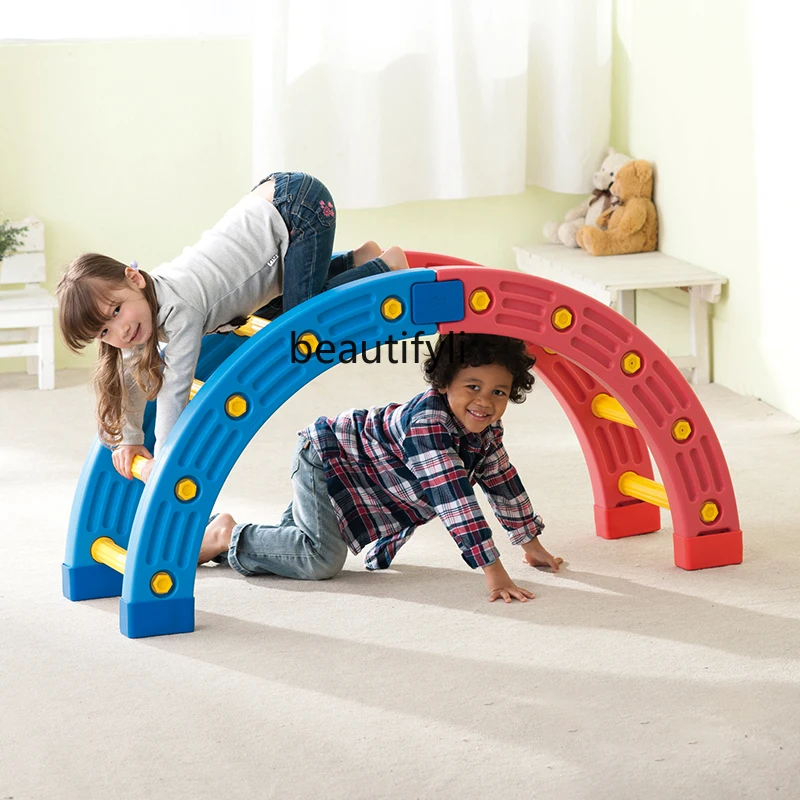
(577, 160, 658, 256)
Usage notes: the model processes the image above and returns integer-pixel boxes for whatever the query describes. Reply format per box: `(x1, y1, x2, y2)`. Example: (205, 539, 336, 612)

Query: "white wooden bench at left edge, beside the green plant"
(0, 217, 57, 389)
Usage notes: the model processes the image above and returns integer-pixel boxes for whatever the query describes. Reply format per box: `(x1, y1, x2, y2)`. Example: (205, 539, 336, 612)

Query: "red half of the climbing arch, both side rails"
(409, 260, 742, 569)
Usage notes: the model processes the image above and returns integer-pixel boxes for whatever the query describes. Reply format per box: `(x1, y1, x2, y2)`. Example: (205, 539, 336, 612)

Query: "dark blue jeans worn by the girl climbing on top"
(250, 172, 389, 319)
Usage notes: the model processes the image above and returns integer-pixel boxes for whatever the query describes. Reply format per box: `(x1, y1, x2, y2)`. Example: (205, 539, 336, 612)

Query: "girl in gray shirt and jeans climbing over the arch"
(57, 172, 408, 480)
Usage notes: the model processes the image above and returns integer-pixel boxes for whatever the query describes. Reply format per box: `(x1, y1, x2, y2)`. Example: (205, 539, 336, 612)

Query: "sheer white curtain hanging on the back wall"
(253, 0, 612, 208)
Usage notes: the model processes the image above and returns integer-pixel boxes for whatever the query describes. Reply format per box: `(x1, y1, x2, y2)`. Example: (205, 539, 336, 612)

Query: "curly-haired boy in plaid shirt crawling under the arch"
(199, 334, 563, 603)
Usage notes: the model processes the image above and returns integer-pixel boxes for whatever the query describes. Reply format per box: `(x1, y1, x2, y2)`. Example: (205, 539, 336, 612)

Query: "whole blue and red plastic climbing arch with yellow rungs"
(62, 252, 742, 638)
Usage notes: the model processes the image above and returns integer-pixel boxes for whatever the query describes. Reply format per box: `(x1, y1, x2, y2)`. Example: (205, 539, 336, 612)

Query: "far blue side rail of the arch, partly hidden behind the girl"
(61, 328, 253, 600)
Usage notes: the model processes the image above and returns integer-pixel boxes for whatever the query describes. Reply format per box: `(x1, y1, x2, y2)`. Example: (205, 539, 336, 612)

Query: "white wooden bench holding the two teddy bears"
(514, 244, 728, 384)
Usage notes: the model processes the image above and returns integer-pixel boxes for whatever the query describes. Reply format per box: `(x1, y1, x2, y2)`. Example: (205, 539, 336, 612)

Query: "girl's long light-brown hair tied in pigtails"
(56, 253, 164, 445)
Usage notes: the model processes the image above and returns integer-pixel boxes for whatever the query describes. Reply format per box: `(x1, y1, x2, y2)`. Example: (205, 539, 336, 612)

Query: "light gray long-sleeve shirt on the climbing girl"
(122, 194, 289, 455)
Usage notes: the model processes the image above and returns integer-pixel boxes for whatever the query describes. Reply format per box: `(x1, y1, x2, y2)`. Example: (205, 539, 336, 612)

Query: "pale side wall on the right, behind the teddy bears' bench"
(612, 0, 800, 418)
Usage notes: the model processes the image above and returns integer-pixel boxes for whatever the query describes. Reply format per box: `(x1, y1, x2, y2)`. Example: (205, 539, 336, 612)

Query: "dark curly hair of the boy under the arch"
(422, 333, 536, 403)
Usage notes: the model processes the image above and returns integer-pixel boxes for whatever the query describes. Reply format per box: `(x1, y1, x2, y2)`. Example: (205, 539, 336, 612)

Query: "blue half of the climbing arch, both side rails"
(64, 269, 444, 638)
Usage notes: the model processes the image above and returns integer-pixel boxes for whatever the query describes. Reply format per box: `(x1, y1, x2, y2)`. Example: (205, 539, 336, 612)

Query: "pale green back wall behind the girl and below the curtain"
(0, 39, 575, 370)
